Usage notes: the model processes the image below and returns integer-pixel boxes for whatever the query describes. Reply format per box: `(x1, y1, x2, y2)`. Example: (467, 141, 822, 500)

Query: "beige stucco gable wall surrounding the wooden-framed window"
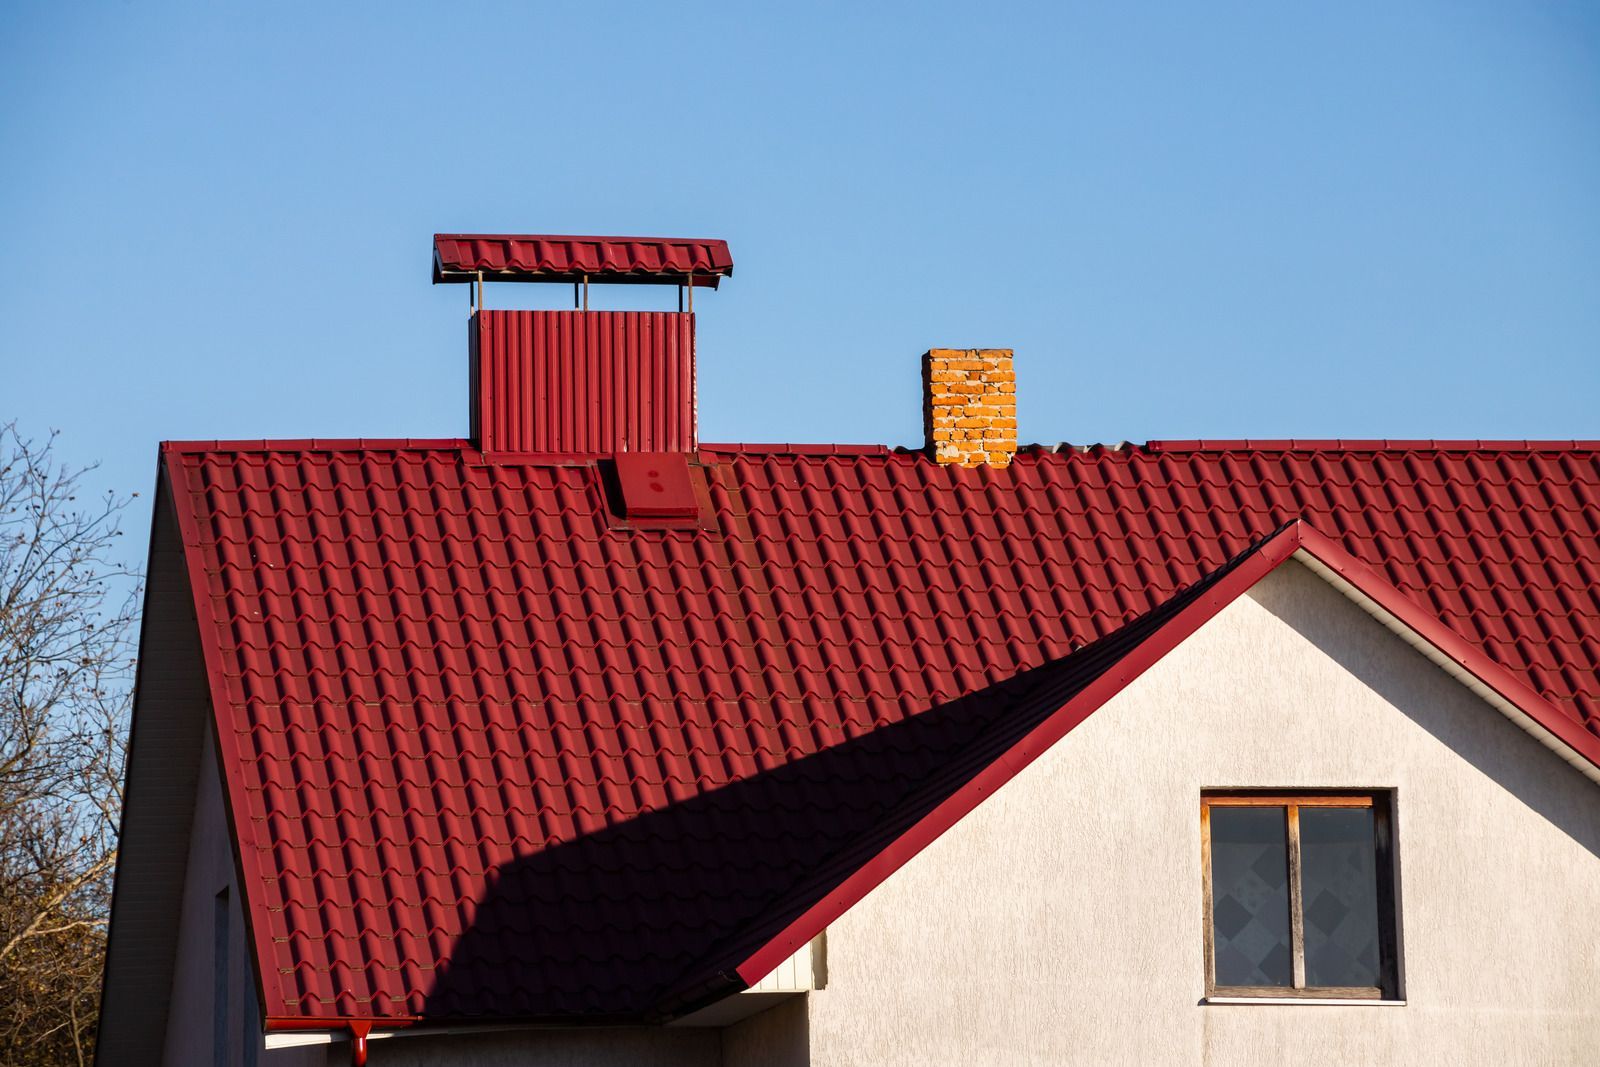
(808, 563, 1600, 1067)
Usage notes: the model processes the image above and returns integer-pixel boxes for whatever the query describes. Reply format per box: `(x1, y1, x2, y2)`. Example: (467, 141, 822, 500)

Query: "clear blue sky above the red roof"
(0, 0, 1600, 566)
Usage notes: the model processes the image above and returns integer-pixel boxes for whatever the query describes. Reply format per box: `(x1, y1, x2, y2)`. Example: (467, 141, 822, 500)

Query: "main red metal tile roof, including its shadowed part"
(156, 442, 1600, 1022)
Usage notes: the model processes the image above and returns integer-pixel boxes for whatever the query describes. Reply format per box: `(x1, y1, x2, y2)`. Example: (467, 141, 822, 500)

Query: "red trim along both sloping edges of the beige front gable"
(738, 520, 1600, 984)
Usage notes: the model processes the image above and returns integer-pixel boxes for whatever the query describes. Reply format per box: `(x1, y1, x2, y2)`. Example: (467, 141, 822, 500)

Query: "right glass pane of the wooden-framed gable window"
(1301, 808, 1378, 985)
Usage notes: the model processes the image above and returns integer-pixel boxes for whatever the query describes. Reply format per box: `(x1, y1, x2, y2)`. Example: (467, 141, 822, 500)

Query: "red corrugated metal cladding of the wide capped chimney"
(472, 310, 696, 454)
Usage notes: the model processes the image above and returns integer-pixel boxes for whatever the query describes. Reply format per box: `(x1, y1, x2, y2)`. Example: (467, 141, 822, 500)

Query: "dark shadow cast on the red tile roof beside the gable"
(422, 542, 1259, 1022)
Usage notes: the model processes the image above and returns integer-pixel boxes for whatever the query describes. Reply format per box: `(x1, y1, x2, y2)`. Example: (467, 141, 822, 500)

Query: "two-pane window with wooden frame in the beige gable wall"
(1200, 792, 1400, 1000)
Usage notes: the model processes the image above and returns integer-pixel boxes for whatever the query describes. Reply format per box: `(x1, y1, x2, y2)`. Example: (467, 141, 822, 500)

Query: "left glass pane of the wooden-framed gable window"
(1211, 808, 1294, 985)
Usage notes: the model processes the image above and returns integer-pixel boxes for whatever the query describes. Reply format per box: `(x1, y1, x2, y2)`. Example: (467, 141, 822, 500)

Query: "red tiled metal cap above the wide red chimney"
(434, 234, 733, 290)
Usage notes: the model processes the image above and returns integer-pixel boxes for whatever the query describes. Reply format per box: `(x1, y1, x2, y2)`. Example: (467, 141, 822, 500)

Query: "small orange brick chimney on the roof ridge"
(922, 349, 1016, 467)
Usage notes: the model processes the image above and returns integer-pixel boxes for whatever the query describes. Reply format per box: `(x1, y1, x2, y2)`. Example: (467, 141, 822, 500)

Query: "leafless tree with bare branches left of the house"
(0, 422, 138, 1067)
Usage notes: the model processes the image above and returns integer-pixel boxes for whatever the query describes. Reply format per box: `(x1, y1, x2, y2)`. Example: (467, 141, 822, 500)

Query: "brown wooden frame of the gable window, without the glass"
(1200, 789, 1400, 1000)
